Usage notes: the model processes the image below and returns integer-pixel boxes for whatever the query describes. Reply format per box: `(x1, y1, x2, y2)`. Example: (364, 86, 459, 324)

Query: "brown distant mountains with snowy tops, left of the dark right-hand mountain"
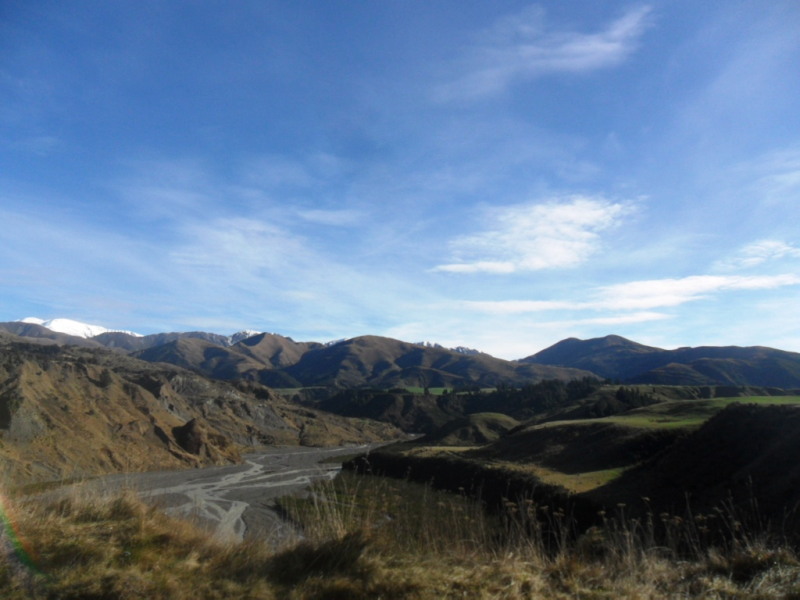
(0, 321, 591, 388)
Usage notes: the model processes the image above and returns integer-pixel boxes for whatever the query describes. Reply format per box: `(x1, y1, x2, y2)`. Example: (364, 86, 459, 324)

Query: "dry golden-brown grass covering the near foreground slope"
(0, 477, 800, 600)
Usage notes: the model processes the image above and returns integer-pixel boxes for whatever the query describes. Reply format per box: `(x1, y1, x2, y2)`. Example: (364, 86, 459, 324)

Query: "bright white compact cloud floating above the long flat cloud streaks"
(434, 196, 631, 273)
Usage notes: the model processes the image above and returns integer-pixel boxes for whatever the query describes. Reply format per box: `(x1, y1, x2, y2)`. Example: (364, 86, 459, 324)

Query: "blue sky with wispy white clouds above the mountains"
(0, 0, 800, 358)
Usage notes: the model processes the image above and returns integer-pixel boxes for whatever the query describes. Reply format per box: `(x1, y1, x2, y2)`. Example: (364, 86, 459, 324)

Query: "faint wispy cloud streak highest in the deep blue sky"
(438, 6, 651, 100)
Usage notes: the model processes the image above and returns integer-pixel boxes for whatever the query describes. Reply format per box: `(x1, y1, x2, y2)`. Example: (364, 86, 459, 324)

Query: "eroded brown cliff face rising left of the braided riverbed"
(0, 339, 396, 483)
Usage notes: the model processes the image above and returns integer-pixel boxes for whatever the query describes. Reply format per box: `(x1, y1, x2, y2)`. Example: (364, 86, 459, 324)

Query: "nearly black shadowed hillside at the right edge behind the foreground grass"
(583, 404, 800, 538)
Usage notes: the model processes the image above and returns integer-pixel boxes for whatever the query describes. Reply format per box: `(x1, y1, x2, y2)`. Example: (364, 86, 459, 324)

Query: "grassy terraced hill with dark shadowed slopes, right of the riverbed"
(355, 388, 800, 528)
